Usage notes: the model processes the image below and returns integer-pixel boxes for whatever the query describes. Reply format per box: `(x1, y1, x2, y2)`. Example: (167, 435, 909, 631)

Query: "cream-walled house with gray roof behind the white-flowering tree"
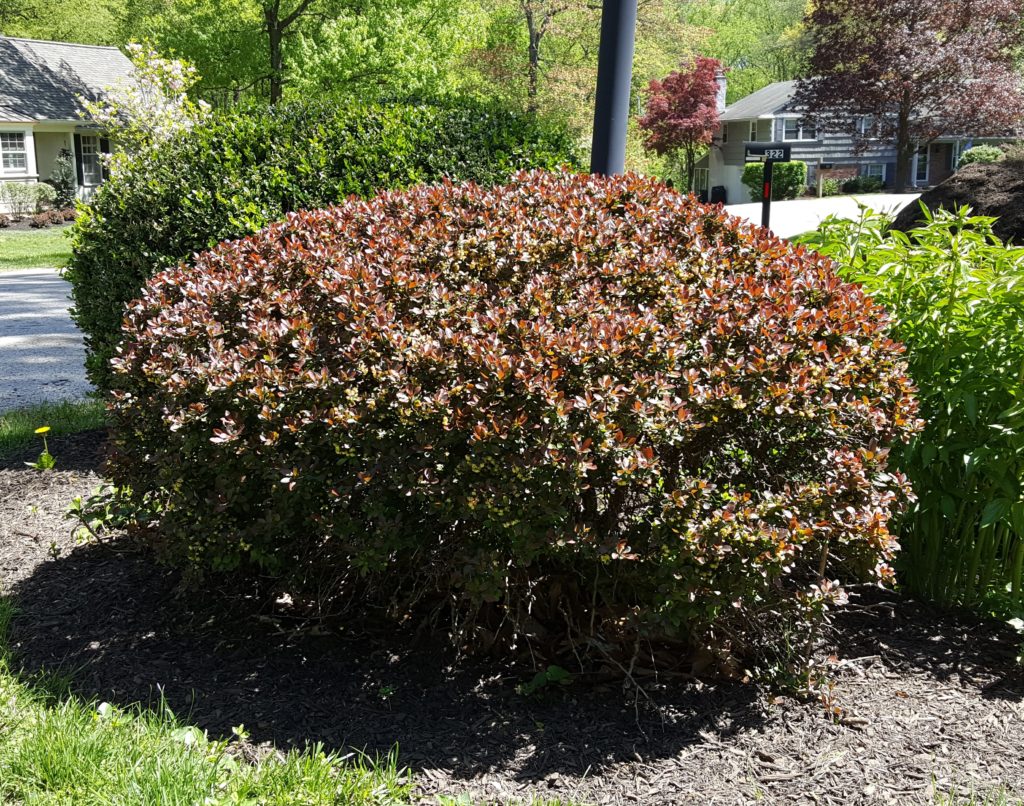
(0, 36, 132, 212)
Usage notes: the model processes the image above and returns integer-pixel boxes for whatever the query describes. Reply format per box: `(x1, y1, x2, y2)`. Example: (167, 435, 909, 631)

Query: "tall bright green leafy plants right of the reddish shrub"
(808, 206, 1024, 612)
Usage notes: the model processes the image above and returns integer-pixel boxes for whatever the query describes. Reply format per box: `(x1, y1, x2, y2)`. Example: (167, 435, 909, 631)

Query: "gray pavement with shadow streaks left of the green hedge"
(0, 268, 91, 412)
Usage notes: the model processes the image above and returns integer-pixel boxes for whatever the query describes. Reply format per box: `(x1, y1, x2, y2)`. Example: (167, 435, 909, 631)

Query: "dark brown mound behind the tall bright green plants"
(894, 159, 1024, 244)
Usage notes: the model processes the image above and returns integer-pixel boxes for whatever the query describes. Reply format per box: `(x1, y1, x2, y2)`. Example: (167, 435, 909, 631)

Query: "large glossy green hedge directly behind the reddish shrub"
(67, 103, 578, 389)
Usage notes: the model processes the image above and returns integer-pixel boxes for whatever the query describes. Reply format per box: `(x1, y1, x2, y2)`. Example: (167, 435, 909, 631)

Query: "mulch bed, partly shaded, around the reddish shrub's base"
(0, 426, 1024, 804)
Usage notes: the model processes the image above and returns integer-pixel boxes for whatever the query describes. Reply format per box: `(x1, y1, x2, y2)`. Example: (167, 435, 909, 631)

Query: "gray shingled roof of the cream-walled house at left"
(0, 36, 132, 121)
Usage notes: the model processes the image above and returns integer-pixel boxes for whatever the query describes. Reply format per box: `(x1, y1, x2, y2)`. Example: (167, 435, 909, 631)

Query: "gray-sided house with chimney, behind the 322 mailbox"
(695, 77, 999, 204)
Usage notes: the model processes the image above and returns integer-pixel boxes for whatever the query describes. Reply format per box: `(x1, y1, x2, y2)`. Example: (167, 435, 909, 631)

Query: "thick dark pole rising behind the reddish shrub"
(590, 0, 637, 176)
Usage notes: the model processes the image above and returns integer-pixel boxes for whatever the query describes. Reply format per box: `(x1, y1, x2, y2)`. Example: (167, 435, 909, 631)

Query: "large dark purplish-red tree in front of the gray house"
(795, 0, 1024, 189)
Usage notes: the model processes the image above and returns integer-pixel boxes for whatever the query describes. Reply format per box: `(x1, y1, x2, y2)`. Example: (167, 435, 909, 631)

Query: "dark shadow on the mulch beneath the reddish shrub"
(11, 539, 764, 781)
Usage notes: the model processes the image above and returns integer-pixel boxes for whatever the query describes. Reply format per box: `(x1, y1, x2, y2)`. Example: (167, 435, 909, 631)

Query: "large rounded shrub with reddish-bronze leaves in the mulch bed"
(112, 171, 916, 675)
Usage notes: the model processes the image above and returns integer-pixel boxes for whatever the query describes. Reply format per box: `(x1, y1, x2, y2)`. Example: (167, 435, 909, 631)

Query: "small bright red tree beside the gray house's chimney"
(639, 56, 722, 189)
